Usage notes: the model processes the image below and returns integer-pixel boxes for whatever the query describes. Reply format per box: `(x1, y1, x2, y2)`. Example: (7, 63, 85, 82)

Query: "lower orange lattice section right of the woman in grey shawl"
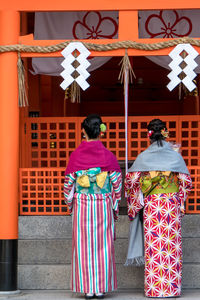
(186, 167, 200, 214)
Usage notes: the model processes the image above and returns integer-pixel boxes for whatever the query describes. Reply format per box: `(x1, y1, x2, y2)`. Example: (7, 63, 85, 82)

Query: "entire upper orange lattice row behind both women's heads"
(21, 116, 200, 168)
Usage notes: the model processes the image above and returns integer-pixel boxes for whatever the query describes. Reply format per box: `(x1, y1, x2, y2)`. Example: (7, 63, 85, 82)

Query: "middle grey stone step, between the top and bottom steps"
(18, 238, 200, 265)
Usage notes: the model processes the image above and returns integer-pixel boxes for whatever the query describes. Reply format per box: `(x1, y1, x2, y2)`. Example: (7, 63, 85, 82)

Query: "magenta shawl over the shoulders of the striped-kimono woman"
(65, 141, 121, 175)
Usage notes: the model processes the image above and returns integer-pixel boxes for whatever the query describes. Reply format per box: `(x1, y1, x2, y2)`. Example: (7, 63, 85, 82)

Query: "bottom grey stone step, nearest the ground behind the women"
(18, 264, 200, 290)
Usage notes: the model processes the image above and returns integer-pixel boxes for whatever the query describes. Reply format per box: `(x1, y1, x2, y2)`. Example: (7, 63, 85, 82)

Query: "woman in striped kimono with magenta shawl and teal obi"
(64, 115, 122, 299)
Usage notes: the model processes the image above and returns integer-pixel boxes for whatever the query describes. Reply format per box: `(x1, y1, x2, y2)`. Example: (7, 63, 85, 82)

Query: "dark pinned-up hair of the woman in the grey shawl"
(147, 119, 167, 147)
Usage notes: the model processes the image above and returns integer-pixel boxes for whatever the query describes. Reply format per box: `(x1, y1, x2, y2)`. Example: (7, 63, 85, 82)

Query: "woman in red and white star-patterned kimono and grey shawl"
(125, 119, 192, 297)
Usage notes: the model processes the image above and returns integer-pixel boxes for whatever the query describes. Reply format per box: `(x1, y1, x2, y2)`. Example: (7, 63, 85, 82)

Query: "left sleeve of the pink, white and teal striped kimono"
(64, 173, 76, 214)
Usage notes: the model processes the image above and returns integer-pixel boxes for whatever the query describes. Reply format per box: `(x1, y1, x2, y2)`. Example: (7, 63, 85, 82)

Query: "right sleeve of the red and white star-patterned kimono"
(178, 173, 192, 215)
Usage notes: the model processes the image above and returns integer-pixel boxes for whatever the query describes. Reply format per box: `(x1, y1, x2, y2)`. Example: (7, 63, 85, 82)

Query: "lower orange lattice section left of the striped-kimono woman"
(20, 168, 69, 215)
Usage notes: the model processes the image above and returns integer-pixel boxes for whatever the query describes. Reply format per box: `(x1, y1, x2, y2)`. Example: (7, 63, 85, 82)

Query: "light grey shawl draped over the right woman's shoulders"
(128, 141, 190, 175)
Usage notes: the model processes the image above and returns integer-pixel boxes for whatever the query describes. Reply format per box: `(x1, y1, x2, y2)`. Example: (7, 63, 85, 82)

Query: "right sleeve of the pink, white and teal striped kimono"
(110, 171, 122, 220)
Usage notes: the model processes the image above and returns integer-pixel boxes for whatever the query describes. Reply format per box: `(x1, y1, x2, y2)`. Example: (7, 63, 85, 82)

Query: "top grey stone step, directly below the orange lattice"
(19, 215, 200, 240)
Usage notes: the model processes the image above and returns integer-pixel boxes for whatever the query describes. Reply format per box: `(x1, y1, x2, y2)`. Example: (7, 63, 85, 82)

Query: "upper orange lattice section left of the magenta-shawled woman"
(23, 118, 80, 168)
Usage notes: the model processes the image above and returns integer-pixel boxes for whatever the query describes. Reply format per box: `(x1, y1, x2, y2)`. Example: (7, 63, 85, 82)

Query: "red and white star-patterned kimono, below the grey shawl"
(125, 172, 192, 297)
